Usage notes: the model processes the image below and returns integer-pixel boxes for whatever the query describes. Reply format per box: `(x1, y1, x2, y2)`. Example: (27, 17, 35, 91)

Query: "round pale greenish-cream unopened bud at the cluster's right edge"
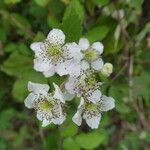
(101, 63, 113, 76)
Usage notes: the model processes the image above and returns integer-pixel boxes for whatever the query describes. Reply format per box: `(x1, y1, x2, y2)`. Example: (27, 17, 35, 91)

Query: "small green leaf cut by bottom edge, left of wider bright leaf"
(63, 138, 80, 150)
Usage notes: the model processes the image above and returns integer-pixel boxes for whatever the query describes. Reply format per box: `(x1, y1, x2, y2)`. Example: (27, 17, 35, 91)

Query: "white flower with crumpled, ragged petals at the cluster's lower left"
(24, 82, 66, 127)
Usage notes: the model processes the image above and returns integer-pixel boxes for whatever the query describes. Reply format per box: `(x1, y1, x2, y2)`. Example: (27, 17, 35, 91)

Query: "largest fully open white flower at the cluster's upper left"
(30, 29, 83, 77)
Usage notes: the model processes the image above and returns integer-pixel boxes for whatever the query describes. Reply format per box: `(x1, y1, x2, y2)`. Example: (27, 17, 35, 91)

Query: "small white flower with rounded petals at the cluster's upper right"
(79, 38, 104, 70)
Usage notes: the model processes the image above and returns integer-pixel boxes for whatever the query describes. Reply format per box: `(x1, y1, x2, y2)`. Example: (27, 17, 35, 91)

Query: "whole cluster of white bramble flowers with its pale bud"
(25, 29, 115, 128)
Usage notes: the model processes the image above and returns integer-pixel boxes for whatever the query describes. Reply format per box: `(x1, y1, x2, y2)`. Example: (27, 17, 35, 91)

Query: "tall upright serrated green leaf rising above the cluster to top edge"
(60, 0, 84, 42)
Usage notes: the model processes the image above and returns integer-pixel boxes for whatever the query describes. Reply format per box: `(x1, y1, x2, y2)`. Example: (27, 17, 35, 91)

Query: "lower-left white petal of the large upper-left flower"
(34, 58, 51, 72)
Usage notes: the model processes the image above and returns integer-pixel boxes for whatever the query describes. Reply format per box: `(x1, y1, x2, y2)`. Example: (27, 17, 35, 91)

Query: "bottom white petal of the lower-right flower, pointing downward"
(86, 114, 101, 129)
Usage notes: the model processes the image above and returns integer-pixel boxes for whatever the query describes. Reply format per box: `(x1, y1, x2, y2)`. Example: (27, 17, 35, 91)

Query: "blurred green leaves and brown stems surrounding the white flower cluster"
(0, 0, 150, 150)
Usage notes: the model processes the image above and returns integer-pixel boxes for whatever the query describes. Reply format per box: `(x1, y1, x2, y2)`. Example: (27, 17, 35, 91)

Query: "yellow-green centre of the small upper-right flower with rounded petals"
(85, 49, 98, 62)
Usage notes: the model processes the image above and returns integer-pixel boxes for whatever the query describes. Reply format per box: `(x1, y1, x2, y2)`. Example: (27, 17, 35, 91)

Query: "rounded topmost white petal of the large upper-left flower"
(47, 29, 65, 45)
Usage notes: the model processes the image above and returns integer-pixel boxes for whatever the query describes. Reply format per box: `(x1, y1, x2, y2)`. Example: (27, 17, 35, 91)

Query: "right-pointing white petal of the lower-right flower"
(101, 95, 115, 111)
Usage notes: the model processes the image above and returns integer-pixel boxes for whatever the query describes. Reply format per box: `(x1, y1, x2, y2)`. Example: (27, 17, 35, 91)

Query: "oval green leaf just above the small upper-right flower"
(85, 26, 109, 42)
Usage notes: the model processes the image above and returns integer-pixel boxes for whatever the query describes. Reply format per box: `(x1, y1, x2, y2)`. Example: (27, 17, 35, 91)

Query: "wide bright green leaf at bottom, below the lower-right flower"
(75, 132, 107, 149)
